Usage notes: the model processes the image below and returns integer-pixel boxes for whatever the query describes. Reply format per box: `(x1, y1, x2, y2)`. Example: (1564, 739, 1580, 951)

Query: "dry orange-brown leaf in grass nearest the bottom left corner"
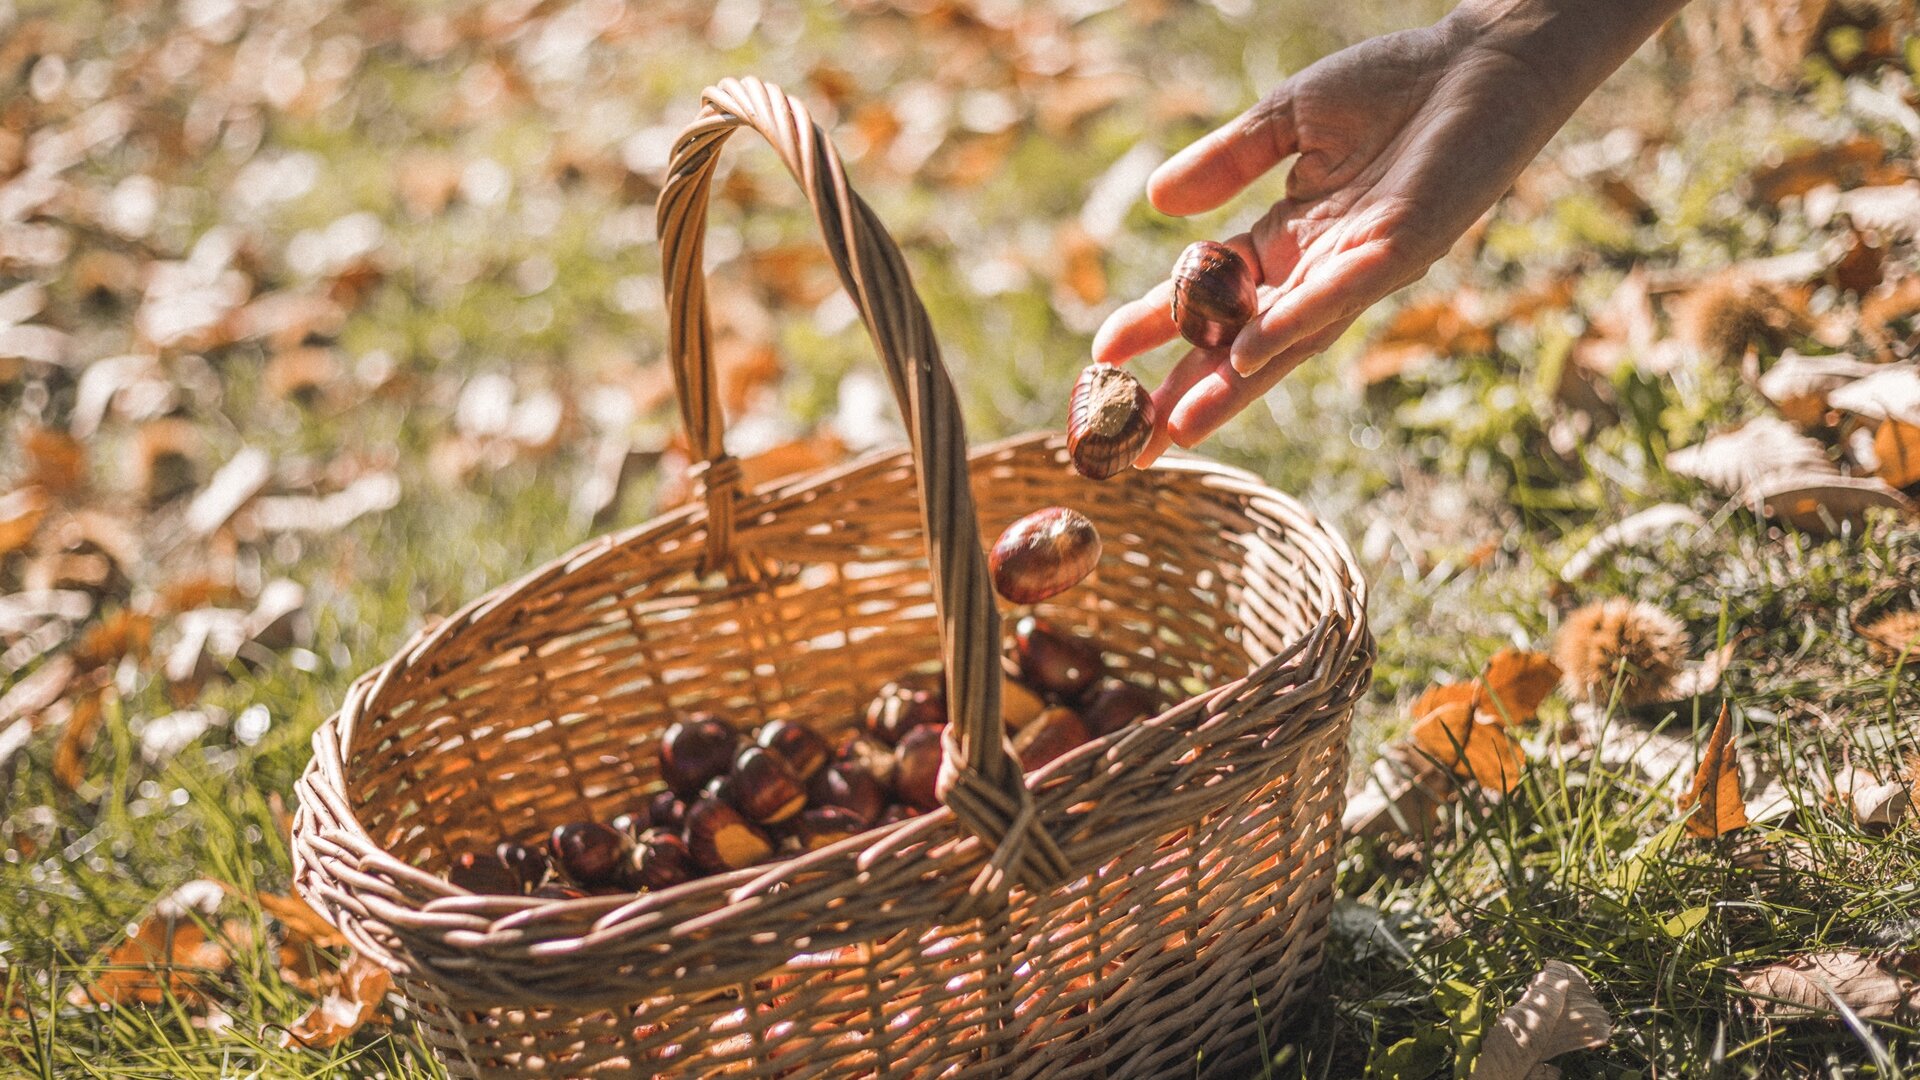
(67, 880, 232, 1005)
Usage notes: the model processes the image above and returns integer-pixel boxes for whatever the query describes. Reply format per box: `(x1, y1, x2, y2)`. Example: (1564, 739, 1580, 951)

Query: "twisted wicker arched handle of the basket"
(657, 77, 1069, 899)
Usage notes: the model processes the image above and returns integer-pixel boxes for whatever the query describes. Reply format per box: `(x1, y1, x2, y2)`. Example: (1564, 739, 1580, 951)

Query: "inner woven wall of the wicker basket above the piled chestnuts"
(346, 436, 1327, 871)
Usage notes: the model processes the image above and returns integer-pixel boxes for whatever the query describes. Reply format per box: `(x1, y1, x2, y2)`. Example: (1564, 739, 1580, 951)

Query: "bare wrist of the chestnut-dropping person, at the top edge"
(1442, 0, 1686, 115)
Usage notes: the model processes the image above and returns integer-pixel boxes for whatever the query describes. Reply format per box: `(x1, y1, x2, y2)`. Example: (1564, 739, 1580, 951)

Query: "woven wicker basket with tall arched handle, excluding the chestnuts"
(294, 79, 1373, 1076)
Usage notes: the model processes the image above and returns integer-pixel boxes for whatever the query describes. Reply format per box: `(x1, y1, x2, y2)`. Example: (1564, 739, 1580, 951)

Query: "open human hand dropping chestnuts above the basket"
(1092, 10, 1620, 467)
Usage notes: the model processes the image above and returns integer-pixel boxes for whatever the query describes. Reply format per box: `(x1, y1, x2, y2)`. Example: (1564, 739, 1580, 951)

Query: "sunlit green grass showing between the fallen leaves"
(0, 0, 1920, 1078)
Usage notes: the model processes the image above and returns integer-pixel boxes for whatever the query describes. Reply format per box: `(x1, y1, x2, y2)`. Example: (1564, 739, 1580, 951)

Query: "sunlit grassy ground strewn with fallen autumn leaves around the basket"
(0, 0, 1920, 1080)
